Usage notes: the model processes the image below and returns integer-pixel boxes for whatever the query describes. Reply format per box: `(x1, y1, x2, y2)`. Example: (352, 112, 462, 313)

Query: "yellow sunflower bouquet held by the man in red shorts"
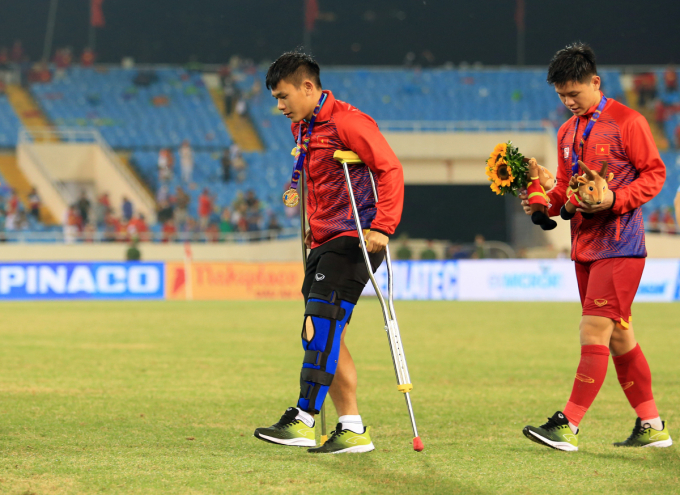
(486, 141, 529, 196)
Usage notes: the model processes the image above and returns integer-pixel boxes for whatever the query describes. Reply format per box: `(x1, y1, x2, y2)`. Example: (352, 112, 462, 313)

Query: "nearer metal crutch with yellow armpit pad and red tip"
(333, 151, 425, 452)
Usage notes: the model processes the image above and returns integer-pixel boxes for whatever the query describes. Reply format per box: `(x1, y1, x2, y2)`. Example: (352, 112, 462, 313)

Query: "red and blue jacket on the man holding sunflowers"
(548, 93, 666, 263)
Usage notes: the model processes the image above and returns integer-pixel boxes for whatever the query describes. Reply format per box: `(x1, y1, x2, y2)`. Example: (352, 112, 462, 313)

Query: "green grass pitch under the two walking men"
(0, 300, 680, 494)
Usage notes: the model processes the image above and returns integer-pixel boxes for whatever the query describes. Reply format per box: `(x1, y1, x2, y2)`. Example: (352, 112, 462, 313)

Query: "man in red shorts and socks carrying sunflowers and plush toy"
(523, 43, 673, 451)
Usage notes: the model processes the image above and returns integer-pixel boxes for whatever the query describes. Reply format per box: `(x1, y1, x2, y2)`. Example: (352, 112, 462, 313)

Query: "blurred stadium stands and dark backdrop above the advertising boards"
(0, 0, 680, 288)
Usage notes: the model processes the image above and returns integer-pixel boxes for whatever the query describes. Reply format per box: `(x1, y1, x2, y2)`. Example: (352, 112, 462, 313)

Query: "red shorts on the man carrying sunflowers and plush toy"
(575, 258, 645, 328)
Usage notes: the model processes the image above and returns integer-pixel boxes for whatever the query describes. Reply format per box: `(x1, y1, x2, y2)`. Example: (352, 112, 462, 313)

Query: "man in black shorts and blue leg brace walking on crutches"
(255, 53, 404, 453)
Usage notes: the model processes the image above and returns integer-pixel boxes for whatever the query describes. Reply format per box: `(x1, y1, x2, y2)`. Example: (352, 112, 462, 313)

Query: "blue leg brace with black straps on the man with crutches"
(298, 294, 355, 413)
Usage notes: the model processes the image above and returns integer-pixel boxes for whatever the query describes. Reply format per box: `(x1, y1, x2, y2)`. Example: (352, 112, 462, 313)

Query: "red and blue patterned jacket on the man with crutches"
(291, 91, 404, 248)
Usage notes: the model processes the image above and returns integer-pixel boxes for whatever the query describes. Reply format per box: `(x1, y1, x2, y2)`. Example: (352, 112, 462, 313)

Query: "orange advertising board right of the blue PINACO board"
(165, 262, 304, 300)
